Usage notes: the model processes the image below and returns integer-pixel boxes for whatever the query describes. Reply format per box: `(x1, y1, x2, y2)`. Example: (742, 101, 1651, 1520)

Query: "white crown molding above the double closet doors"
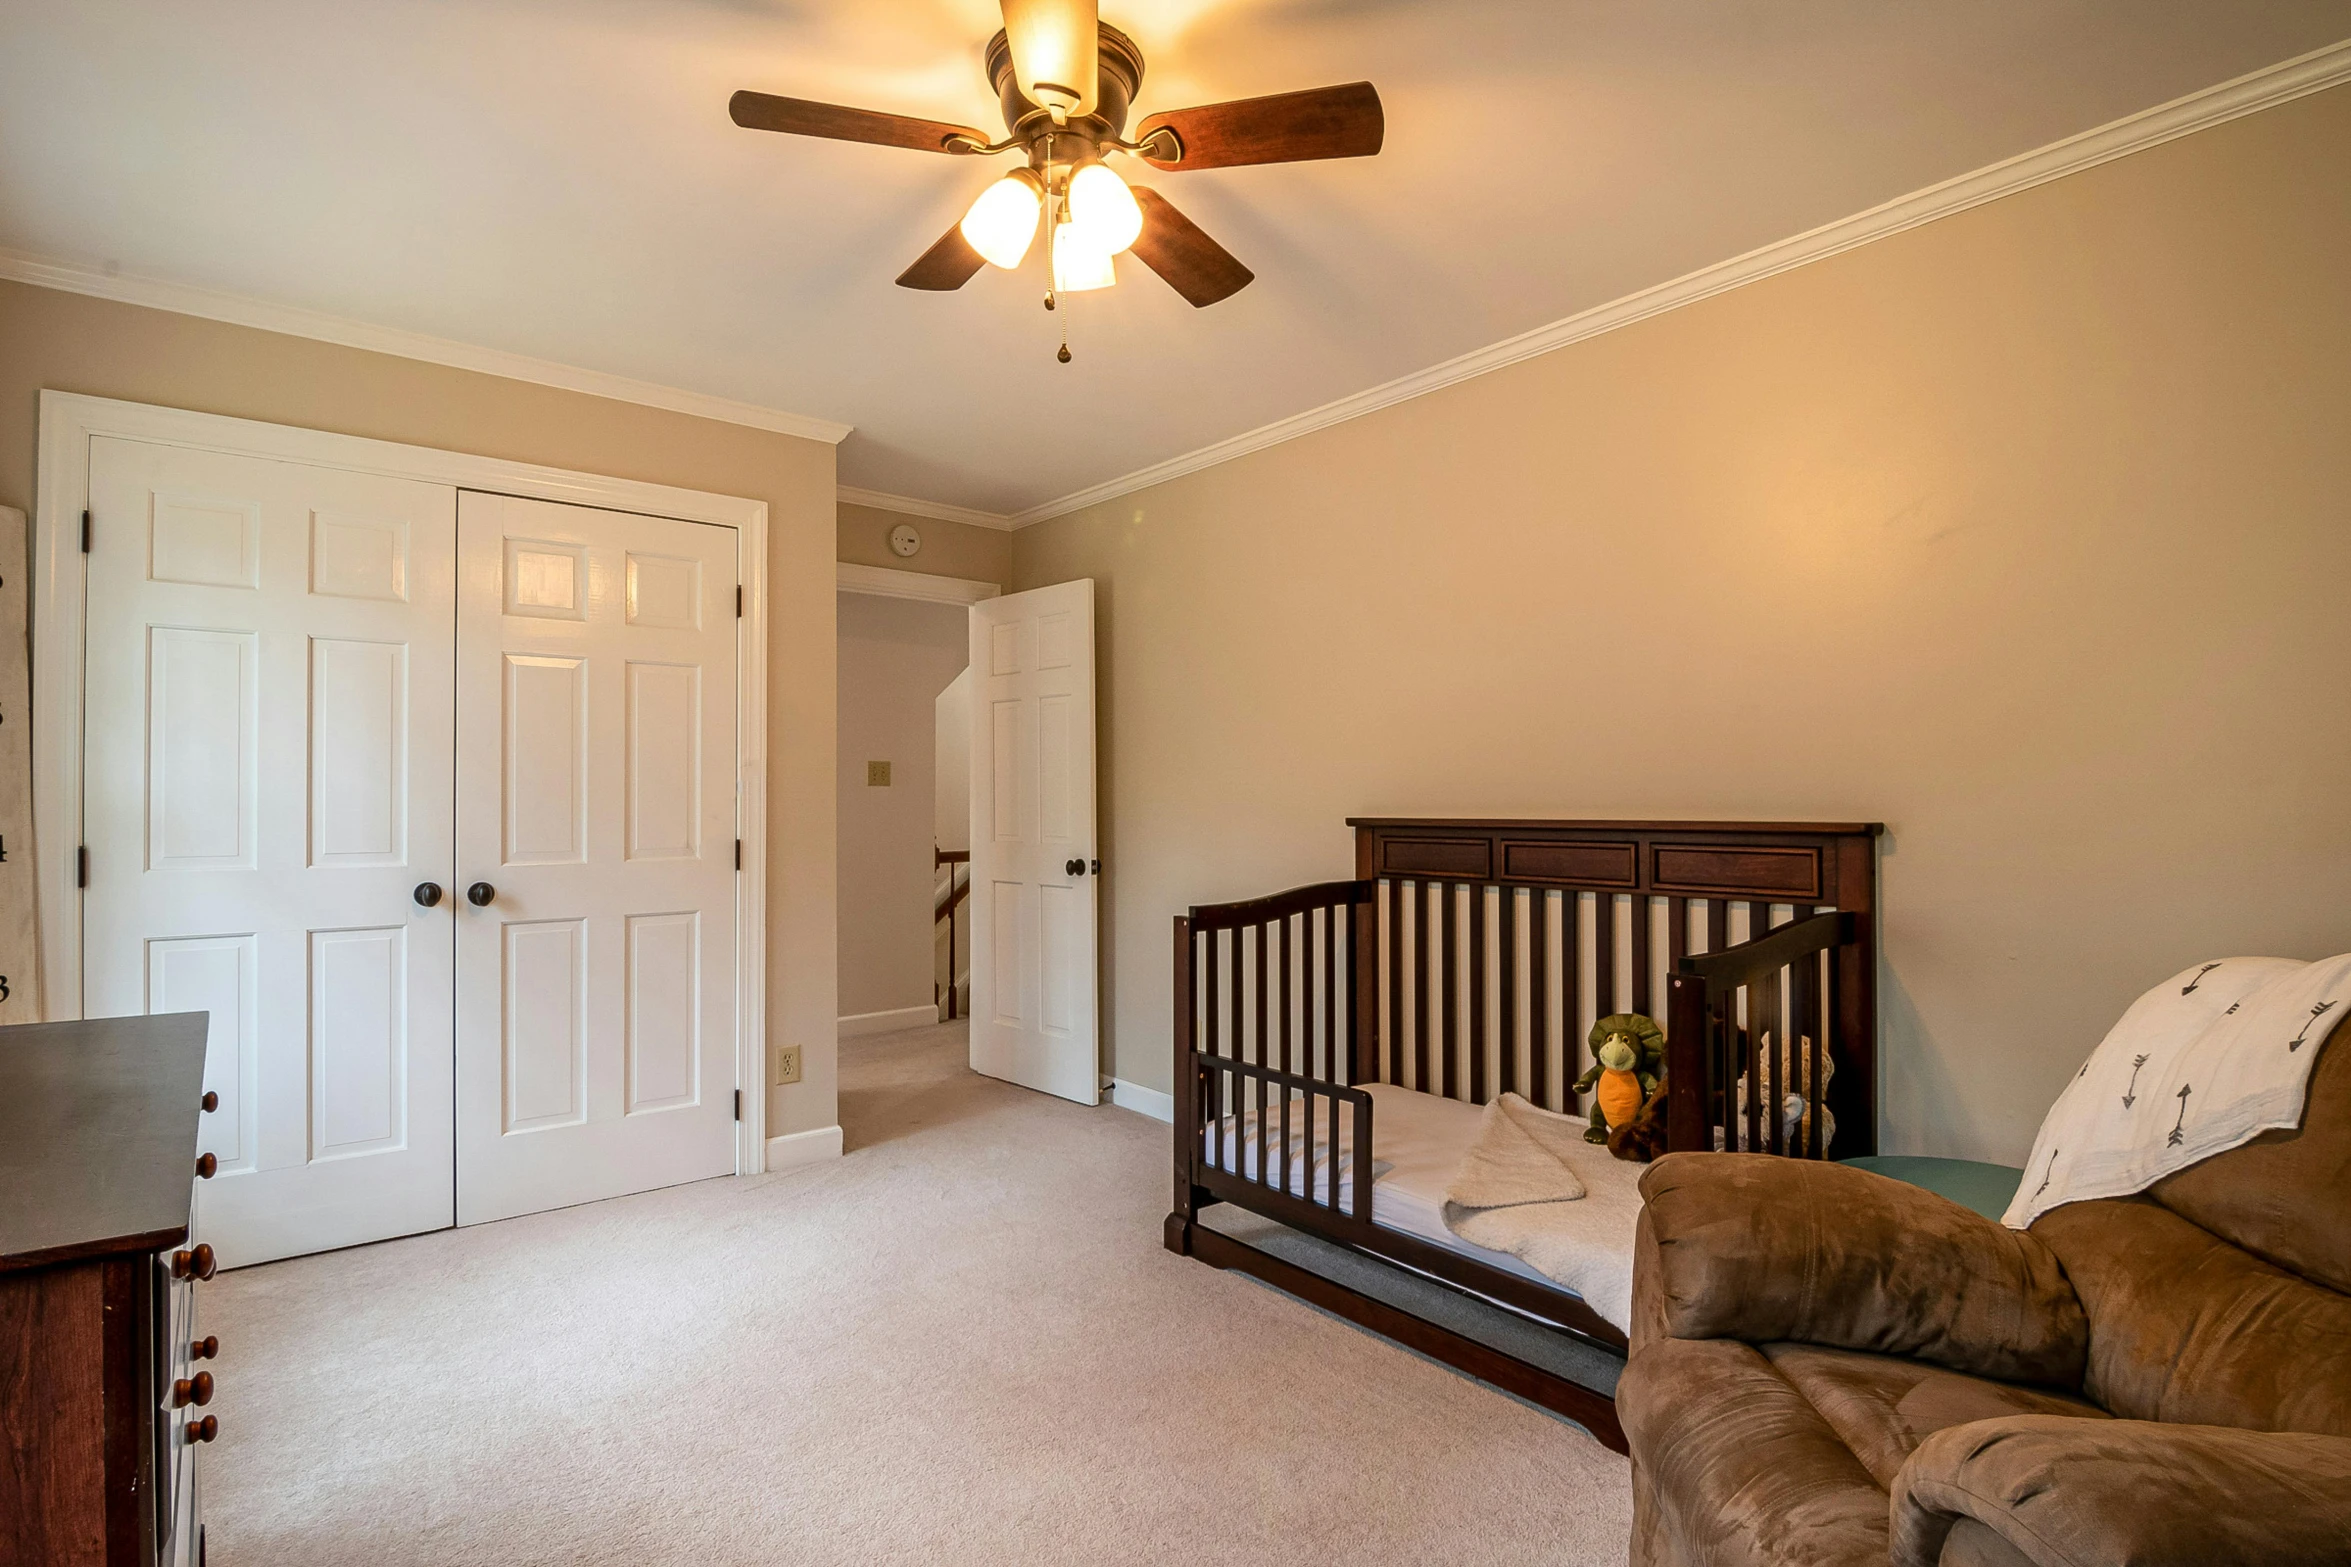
(0, 249, 851, 446)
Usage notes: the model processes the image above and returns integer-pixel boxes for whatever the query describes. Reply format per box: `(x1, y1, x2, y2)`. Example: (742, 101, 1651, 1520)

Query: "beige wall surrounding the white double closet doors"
(0, 282, 837, 1135)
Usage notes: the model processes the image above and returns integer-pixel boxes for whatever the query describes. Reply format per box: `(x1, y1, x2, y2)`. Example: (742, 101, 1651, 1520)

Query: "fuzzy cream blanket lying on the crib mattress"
(1444, 1095, 1641, 1332)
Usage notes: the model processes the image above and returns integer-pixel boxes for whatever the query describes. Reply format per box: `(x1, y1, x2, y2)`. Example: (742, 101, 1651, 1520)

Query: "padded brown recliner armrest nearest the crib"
(1634, 1154, 2090, 1388)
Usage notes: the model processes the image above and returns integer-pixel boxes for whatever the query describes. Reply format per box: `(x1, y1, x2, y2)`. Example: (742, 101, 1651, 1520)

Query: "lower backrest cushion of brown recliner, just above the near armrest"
(2034, 1188, 2351, 1435)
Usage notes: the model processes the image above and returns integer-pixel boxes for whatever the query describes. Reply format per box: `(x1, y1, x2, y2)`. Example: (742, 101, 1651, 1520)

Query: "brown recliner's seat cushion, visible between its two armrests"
(1763, 1344, 2106, 1489)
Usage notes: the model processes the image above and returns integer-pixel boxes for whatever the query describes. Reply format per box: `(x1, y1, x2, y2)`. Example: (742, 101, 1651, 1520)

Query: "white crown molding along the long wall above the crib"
(1011, 40, 2351, 529)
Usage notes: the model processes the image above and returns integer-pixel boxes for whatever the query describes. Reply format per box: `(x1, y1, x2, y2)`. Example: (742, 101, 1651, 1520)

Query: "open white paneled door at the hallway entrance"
(971, 580, 1103, 1104)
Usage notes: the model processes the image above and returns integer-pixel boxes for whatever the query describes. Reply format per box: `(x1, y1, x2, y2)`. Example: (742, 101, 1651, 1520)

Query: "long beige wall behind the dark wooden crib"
(1013, 89, 2351, 1163)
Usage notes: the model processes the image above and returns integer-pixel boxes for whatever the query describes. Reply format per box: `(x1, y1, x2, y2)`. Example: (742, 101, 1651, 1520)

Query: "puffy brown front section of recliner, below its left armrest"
(1617, 1339, 1890, 1567)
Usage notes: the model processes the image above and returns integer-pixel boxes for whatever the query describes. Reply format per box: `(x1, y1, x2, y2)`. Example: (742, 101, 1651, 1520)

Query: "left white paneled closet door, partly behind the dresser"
(80, 439, 456, 1266)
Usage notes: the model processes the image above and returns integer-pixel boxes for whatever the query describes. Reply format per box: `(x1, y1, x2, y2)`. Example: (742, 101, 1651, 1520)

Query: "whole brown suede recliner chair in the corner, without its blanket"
(1617, 1029, 2351, 1567)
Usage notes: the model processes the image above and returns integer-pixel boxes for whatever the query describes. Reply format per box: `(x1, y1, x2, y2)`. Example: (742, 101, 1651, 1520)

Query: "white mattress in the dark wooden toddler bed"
(1220, 1083, 1646, 1294)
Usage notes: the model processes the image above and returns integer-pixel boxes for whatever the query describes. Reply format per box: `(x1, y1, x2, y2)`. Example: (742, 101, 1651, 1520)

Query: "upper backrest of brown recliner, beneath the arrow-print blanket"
(2149, 1027, 2351, 1292)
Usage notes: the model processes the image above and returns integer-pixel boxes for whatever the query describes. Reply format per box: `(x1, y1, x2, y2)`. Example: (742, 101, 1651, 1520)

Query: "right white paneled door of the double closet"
(454, 491, 736, 1224)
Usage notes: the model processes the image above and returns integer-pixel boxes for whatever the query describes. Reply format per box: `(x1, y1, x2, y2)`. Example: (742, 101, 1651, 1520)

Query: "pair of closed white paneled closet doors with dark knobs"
(80, 437, 738, 1266)
